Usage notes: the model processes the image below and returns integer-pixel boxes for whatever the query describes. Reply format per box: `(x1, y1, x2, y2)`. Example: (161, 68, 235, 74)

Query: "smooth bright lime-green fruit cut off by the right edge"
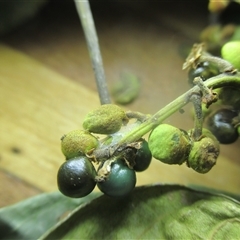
(221, 41, 240, 69)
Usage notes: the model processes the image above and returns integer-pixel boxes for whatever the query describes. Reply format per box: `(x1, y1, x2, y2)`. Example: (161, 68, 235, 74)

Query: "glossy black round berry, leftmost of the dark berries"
(57, 156, 96, 198)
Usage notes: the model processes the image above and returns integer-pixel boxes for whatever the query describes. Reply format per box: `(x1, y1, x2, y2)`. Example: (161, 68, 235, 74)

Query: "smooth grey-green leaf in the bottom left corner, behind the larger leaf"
(0, 192, 99, 240)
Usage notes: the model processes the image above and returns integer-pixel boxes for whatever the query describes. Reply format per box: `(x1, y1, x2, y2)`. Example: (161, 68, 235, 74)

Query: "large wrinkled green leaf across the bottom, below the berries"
(40, 185, 240, 240)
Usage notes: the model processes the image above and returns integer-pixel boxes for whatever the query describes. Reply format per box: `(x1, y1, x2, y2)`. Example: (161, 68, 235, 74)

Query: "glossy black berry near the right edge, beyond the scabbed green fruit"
(206, 108, 238, 144)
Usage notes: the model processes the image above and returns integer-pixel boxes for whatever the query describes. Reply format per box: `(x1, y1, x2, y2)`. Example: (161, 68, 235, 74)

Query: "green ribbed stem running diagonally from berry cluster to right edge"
(117, 73, 240, 145)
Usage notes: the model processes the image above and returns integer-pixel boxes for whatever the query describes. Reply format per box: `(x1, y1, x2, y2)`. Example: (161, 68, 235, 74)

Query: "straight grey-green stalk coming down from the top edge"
(74, 0, 111, 104)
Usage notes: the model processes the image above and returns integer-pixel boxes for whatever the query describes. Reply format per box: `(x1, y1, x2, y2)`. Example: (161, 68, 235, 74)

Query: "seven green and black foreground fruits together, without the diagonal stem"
(57, 104, 219, 197)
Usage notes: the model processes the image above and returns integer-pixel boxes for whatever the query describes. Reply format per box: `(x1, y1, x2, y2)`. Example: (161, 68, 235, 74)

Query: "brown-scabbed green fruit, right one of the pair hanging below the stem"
(187, 129, 220, 173)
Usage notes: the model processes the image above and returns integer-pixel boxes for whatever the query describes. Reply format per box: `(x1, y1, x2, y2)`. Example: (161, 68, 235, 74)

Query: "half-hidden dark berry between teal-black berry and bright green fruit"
(133, 140, 152, 172)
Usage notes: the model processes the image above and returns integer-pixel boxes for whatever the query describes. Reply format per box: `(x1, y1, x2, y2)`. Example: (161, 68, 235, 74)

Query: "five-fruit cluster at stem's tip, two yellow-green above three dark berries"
(57, 104, 152, 198)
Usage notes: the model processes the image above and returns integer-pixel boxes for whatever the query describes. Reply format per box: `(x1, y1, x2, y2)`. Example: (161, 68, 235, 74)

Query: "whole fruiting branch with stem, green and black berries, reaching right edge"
(57, 43, 240, 198)
